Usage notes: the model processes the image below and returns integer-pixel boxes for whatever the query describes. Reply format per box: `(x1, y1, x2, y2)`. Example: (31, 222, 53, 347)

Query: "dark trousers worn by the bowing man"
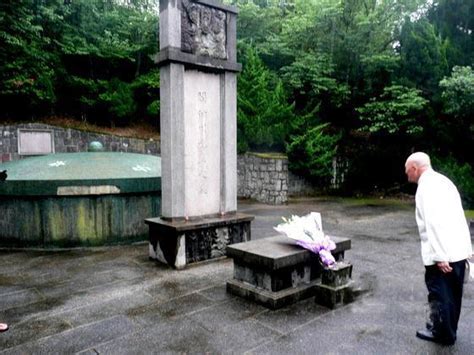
(425, 260, 466, 341)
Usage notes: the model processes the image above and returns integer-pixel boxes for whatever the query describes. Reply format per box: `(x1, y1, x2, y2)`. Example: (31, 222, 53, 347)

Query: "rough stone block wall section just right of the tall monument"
(237, 153, 314, 205)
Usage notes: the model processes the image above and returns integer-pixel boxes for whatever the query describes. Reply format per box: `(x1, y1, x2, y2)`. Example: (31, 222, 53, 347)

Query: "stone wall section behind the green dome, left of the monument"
(0, 123, 160, 162)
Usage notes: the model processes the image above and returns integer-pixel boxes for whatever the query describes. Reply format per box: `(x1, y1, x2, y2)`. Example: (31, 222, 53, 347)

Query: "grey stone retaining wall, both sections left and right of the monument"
(0, 123, 314, 205)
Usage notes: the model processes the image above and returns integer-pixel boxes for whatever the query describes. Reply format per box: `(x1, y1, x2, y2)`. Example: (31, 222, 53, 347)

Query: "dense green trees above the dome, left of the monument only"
(0, 0, 159, 125)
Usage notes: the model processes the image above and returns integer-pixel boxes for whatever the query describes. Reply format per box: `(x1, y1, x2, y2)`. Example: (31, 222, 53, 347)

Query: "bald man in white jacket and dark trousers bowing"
(405, 152, 472, 345)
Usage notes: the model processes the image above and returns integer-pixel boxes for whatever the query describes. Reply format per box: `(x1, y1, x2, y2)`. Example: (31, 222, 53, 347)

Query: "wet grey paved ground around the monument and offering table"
(0, 199, 474, 354)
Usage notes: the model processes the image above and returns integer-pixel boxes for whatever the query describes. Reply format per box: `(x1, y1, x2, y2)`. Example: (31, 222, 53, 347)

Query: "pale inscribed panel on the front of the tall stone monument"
(183, 69, 221, 216)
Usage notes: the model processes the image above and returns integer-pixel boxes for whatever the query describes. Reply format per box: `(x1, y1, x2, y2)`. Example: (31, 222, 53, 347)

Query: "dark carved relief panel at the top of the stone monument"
(181, 0, 227, 59)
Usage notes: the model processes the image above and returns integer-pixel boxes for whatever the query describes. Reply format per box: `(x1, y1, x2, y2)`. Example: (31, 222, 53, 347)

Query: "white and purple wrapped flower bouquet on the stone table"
(274, 212, 336, 266)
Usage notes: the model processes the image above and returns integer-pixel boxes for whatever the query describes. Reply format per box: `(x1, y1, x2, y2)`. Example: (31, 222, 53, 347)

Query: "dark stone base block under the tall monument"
(145, 213, 254, 269)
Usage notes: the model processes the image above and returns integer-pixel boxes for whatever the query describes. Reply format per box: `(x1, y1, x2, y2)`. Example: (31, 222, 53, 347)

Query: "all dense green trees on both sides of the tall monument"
(0, 0, 474, 203)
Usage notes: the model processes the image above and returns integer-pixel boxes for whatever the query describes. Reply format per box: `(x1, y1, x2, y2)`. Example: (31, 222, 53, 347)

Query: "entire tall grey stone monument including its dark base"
(145, 0, 253, 268)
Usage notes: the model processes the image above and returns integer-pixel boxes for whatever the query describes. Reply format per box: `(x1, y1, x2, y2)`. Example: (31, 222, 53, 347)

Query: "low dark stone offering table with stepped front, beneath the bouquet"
(226, 235, 352, 309)
